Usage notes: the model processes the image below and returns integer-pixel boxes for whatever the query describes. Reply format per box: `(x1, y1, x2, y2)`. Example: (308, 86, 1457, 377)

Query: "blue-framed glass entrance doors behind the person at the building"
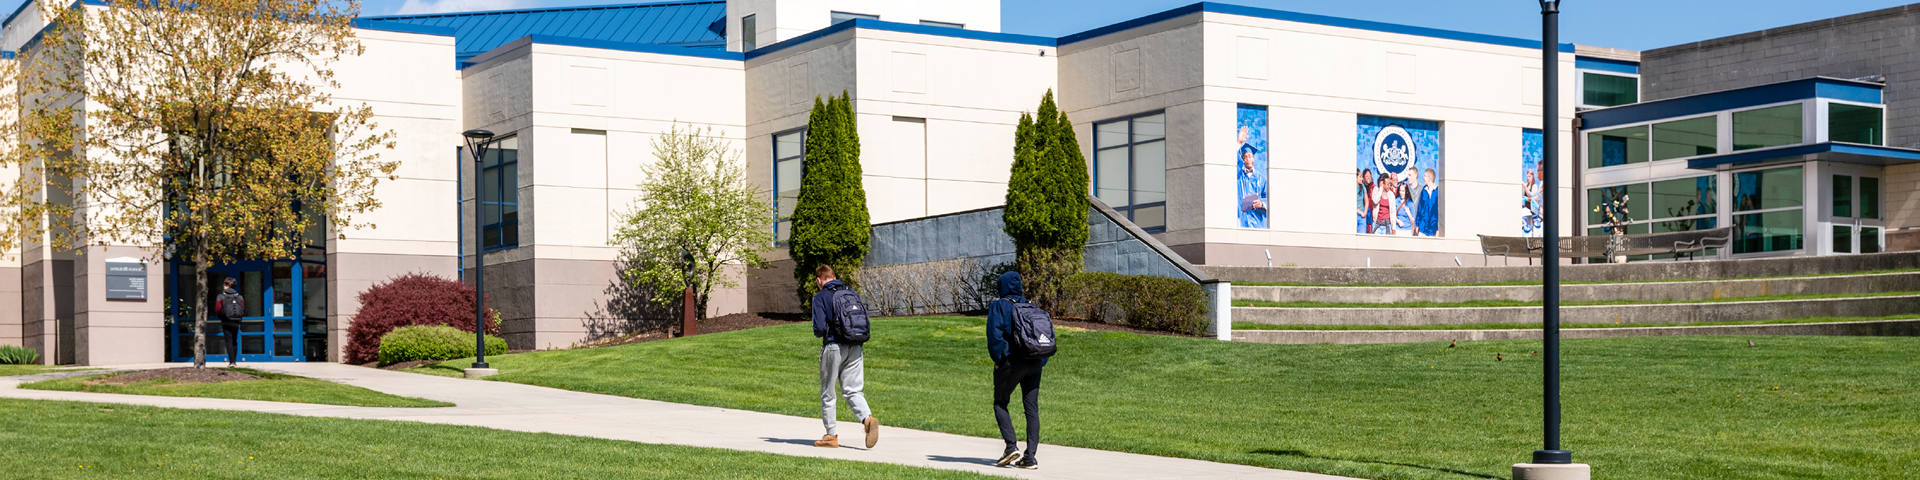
(167, 259, 314, 363)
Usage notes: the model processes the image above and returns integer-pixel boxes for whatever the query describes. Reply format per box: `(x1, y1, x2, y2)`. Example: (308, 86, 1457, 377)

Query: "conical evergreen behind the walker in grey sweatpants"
(783, 92, 872, 307)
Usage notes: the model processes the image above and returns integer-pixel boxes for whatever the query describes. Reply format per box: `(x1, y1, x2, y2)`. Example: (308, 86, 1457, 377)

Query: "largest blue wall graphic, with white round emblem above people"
(1354, 115, 1444, 236)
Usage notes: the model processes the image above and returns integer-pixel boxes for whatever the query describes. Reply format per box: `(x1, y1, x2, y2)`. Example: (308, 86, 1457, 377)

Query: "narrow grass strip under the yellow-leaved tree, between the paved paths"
(19, 369, 453, 407)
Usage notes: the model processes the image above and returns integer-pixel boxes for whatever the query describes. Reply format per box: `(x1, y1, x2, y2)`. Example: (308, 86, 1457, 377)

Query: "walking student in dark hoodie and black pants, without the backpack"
(987, 273, 1046, 468)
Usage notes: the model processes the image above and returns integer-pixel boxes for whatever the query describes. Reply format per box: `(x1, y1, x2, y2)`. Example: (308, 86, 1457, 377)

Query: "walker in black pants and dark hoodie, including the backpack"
(987, 273, 1054, 468)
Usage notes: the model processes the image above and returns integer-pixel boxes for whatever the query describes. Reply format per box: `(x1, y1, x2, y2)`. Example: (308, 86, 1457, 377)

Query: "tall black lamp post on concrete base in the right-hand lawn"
(1534, 0, 1572, 465)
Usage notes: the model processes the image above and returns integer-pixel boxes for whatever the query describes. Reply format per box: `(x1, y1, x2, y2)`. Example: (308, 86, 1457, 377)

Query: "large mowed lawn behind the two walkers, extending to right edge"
(428, 317, 1920, 480)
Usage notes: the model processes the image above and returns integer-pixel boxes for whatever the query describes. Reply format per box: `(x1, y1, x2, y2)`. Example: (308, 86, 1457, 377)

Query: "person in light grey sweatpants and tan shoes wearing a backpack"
(812, 265, 879, 447)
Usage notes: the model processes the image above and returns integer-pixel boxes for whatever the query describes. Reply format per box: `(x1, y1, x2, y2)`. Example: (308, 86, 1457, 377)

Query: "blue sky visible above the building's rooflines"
(0, 0, 1912, 50)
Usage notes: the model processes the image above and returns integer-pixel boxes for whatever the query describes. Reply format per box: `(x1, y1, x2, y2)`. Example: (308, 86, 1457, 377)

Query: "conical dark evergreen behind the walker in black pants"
(1002, 90, 1089, 309)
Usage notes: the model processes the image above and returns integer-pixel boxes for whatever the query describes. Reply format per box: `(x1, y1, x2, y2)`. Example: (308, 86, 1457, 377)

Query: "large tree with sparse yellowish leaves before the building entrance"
(0, 0, 399, 367)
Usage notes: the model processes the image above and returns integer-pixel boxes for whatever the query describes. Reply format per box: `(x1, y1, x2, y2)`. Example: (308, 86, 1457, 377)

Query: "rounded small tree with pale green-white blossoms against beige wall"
(614, 123, 774, 326)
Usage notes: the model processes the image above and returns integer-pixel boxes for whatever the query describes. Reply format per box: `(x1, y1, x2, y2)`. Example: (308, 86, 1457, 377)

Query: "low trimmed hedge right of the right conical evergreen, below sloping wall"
(1060, 273, 1208, 334)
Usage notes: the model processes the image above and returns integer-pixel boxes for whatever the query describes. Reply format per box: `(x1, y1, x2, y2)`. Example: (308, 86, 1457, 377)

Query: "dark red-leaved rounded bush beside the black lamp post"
(346, 273, 499, 363)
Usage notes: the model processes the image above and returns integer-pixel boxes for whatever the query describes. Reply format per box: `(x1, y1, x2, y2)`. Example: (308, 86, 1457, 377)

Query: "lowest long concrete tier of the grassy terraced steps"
(1233, 319, 1920, 344)
